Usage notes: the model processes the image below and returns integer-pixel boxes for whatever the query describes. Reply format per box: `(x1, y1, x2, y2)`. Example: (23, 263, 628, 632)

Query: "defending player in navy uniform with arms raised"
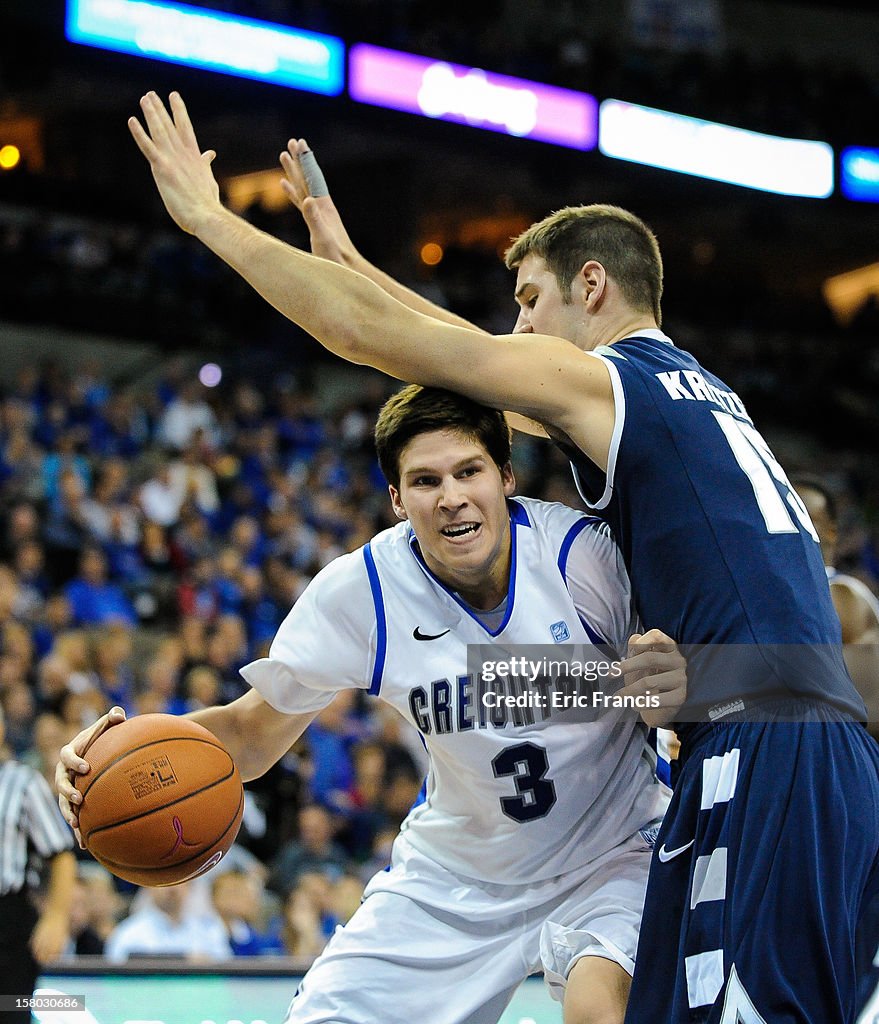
(129, 93, 879, 1024)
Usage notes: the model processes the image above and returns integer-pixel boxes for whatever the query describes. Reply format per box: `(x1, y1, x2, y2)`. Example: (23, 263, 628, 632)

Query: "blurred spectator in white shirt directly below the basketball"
(104, 882, 232, 964)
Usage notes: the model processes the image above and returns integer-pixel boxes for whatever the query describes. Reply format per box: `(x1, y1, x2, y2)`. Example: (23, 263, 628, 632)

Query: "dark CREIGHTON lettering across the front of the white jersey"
(409, 675, 584, 736)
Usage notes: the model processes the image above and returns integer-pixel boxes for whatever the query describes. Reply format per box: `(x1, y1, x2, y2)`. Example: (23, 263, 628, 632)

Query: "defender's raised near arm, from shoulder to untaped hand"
(129, 93, 602, 468)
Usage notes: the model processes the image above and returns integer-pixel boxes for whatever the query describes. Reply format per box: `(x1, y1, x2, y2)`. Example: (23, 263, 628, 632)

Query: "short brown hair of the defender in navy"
(504, 203, 663, 324)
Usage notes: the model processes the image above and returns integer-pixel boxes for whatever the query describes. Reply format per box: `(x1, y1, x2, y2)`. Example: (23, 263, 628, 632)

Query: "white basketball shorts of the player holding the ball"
(287, 833, 652, 1024)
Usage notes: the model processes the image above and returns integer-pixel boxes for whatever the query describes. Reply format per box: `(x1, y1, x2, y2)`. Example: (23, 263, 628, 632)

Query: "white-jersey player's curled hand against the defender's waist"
(618, 630, 686, 728)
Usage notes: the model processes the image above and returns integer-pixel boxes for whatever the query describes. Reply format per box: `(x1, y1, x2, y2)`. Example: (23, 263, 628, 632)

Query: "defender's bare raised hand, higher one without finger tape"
(128, 92, 223, 234)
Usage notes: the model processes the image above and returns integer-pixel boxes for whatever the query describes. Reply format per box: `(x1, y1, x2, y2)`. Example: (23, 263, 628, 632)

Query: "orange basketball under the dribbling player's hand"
(76, 715, 244, 886)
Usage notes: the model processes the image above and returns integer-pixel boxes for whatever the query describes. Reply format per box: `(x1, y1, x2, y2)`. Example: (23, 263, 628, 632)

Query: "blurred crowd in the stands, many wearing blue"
(0, 348, 879, 959)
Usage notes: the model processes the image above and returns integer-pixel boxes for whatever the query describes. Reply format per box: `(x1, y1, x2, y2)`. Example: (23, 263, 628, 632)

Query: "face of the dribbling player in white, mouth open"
(390, 430, 515, 608)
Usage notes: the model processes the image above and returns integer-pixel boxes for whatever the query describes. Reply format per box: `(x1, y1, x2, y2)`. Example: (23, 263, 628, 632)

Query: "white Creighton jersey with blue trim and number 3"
(242, 498, 668, 884)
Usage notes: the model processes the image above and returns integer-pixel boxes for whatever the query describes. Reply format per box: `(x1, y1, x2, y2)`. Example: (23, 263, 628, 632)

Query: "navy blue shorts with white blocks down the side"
(626, 707, 879, 1024)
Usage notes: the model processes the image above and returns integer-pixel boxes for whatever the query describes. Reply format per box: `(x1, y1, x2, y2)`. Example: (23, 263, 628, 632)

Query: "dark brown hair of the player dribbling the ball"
(375, 384, 512, 490)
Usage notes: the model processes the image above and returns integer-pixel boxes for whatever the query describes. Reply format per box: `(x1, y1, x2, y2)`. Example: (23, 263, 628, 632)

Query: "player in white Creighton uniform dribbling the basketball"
(56, 386, 685, 1024)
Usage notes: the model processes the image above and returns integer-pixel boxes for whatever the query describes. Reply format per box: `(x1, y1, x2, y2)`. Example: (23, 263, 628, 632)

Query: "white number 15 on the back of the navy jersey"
(714, 412, 818, 544)
